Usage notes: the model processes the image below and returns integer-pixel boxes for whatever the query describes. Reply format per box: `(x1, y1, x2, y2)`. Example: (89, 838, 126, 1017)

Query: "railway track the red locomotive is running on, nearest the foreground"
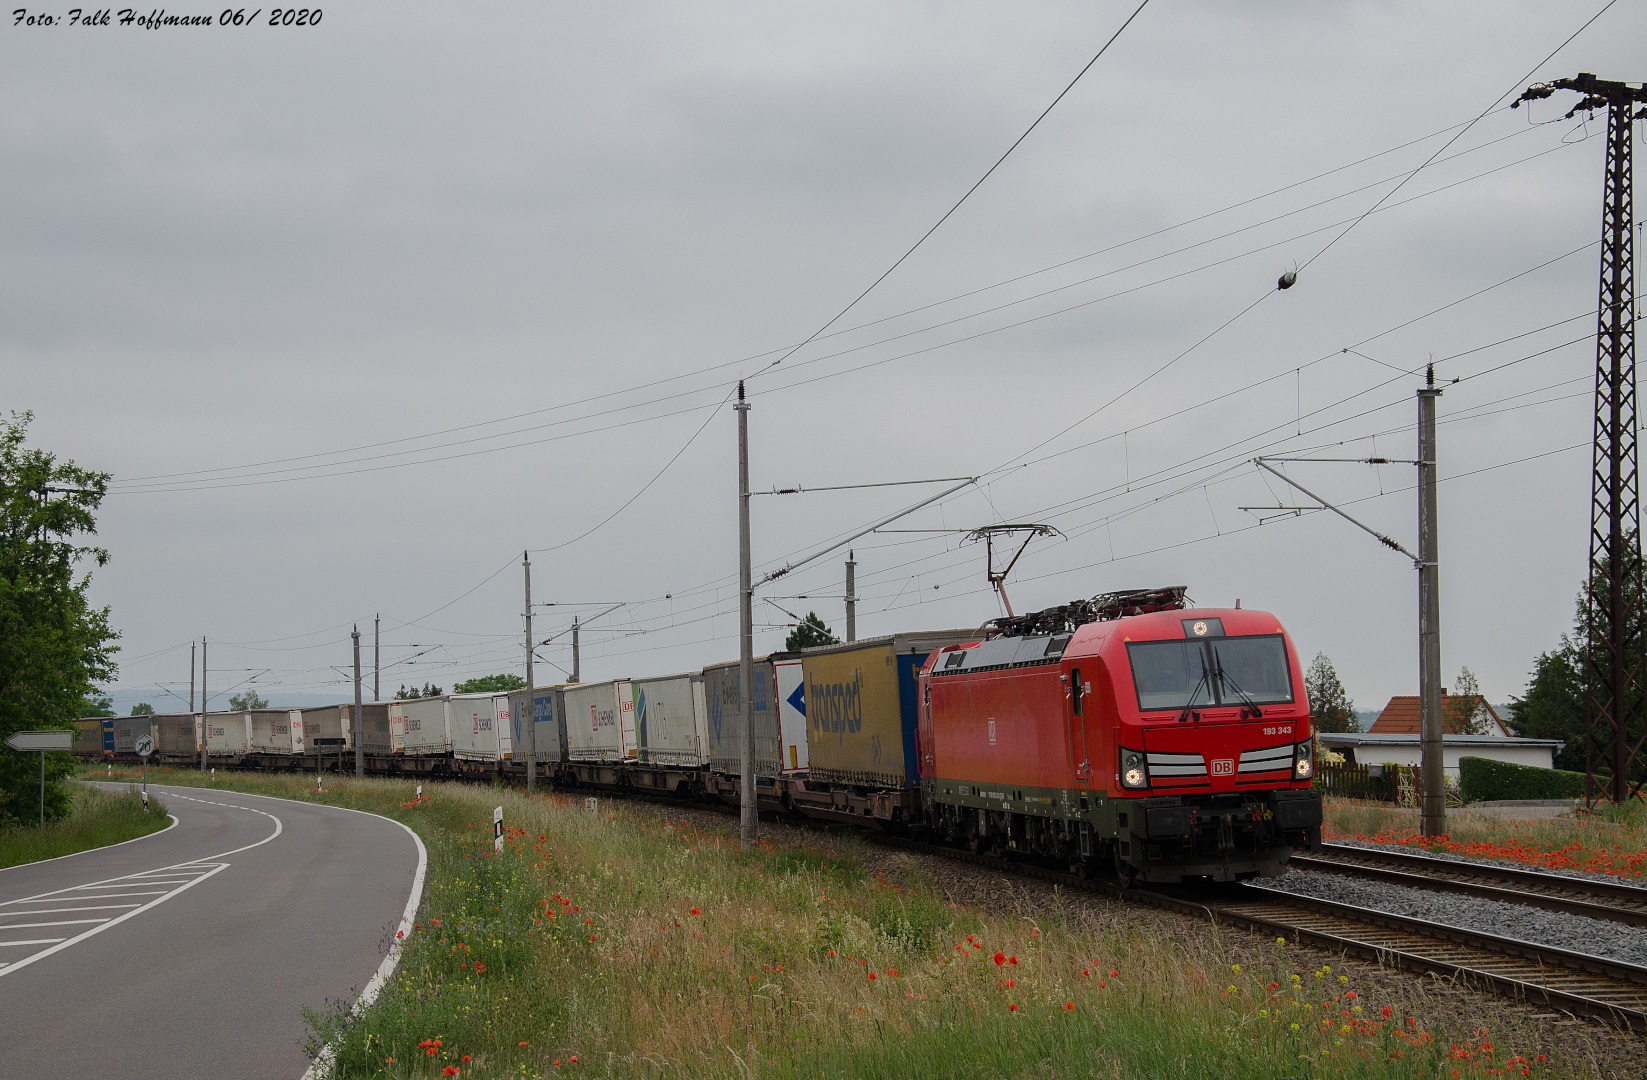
(873, 836, 1647, 1034)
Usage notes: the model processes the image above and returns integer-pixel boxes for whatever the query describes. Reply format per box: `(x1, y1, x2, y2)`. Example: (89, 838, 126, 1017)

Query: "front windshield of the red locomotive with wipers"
(1127, 634, 1293, 711)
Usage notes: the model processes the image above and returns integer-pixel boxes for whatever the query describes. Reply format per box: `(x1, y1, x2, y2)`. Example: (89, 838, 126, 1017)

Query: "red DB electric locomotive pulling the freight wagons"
(919, 586, 1321, 882)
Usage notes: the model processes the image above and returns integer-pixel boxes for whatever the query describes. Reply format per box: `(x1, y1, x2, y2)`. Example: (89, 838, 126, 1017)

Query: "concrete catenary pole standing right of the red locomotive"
(1418, 367, 1446, 836)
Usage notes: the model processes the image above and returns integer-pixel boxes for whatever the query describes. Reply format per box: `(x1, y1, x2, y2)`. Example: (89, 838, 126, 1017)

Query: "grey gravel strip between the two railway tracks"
(1258, 869, 1647, 966)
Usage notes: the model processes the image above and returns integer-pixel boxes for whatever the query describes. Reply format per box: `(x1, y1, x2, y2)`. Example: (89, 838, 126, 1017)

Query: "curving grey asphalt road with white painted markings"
(0, 785, 420, 1080)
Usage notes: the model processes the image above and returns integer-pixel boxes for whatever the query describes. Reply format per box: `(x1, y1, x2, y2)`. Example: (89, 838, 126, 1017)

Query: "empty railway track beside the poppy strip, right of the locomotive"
(1290, 845, 1647, 927)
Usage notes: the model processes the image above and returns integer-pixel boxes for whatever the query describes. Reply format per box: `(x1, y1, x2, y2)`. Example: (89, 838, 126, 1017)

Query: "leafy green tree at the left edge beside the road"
(0, 412, 120, 825)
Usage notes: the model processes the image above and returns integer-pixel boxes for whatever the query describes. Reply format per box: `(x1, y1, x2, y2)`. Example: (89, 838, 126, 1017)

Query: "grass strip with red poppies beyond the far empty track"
(1321, 798, 1647, 881)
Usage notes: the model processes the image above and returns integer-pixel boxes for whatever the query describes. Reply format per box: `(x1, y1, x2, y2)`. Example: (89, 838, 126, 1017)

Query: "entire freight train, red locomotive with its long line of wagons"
(74, 586, 1321, 882)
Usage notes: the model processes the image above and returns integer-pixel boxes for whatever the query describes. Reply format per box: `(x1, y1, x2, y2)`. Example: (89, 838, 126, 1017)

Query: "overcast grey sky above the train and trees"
(0, 0, 1647, 711)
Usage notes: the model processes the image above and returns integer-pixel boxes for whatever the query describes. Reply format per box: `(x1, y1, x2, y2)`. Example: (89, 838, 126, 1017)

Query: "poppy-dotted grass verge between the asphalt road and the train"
(83, 763, 1588, 1080)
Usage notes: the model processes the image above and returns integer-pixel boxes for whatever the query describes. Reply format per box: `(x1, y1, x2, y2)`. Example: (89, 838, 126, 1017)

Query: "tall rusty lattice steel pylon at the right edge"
(1515, 72, 1647, 805)
